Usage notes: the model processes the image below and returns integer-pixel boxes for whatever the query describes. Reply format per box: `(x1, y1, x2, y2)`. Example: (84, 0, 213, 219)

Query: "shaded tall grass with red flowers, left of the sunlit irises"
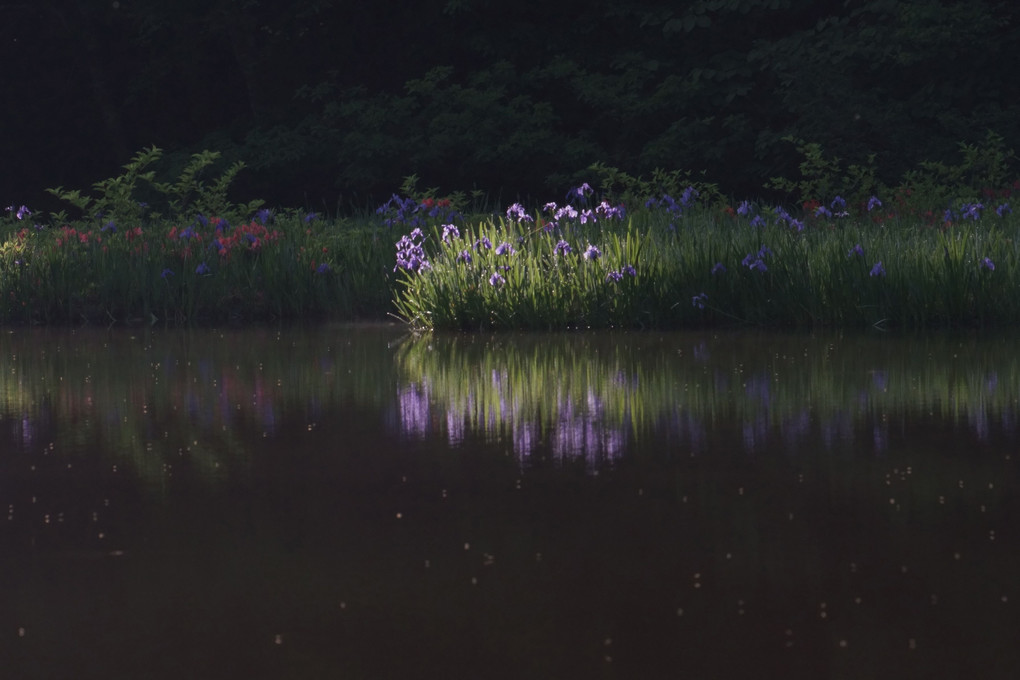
(0, 212, 393, 324)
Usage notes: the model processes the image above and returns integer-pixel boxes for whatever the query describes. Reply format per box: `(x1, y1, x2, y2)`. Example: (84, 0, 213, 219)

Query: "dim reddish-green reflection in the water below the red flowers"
(0, 327, 405, 481)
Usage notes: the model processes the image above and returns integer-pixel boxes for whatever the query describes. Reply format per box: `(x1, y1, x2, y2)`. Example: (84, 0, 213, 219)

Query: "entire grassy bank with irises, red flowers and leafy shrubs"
(0, 149, 1020, 330)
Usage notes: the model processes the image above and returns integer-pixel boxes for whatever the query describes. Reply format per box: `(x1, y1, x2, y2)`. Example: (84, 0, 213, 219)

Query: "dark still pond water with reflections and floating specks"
(0, 325, 1020, 679)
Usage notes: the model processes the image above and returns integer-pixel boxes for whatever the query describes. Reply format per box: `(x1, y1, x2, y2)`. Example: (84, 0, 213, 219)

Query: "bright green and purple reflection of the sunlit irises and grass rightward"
(398, 333, 1020, 459)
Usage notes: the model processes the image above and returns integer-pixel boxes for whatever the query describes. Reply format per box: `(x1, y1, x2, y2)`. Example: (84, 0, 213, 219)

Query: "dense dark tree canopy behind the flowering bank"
(0, 0, 1020, 211)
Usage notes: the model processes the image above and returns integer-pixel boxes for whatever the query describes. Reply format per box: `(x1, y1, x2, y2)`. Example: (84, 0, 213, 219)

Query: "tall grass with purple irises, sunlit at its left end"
(396, 197, 1020, 329)
